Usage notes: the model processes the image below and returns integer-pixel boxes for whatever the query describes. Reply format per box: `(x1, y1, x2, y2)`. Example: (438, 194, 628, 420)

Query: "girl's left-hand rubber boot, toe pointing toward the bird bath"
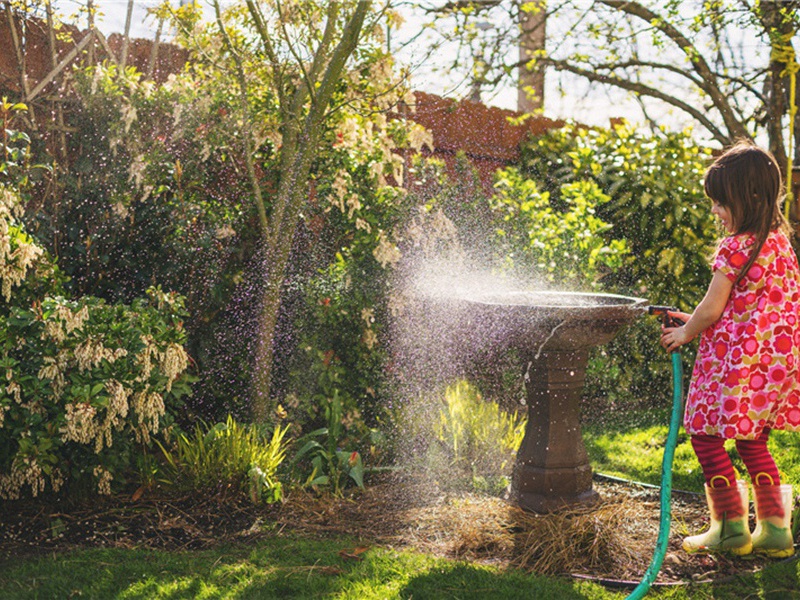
(683, 481, 753, 556)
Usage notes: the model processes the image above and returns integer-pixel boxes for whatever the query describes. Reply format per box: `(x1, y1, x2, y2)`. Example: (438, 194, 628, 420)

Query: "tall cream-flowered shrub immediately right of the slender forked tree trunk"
(284, 97, 432, 460)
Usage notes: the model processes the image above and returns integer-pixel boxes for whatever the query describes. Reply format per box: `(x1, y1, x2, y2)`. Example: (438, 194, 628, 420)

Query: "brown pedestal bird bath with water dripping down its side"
(449, 291, 647, 512)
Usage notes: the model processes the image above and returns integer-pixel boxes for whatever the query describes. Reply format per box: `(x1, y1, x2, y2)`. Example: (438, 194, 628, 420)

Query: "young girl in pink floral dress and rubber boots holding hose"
(661, 142, 800, 557)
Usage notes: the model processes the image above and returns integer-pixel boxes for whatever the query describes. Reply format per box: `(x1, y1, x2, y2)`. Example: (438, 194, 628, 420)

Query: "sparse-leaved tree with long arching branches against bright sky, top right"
(415, 0, 800, 164)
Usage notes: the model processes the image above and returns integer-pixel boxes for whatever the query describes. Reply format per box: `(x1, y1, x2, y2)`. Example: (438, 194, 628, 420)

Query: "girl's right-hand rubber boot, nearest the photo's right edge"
(753, 478, 794, 558)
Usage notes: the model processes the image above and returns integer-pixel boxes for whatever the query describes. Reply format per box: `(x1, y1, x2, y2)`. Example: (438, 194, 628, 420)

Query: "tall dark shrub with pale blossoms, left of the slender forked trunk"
(39, 64, 260, 424)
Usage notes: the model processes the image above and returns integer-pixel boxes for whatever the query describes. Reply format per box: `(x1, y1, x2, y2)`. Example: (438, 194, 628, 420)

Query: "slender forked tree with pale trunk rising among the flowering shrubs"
(197, 0, 410, 420)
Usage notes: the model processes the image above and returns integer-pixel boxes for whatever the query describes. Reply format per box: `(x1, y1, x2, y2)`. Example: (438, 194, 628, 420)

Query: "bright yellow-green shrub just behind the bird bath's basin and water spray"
(406, 155, 630, 408)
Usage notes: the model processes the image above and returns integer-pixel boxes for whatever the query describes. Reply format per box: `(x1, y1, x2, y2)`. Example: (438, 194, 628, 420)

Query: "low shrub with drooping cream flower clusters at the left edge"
(0, 188, 189, 499)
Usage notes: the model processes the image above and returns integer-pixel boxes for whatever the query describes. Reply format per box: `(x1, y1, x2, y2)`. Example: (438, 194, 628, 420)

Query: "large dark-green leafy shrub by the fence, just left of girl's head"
(520, 123, 718, 404)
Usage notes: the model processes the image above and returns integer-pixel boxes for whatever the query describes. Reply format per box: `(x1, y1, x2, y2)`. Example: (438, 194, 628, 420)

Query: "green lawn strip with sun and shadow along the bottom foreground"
(0, 535, 800, 600)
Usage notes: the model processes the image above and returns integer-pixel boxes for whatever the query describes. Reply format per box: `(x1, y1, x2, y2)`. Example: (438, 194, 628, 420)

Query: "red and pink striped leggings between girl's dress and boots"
(691, 429, 780, 487)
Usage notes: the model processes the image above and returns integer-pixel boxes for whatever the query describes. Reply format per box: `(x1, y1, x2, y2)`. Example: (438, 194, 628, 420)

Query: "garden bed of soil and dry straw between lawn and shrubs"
(0, 476, 792, 586)
